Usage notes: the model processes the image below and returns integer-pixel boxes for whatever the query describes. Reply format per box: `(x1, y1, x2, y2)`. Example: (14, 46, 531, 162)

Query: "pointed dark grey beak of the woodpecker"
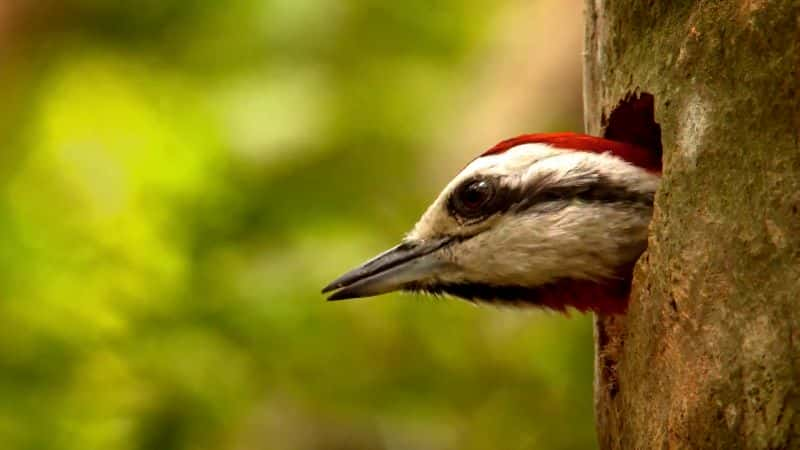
(322, 238, 452, 301)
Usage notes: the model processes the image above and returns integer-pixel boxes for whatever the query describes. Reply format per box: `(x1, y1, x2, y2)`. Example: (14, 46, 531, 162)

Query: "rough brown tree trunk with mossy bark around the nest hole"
(584, 0, 800, 449)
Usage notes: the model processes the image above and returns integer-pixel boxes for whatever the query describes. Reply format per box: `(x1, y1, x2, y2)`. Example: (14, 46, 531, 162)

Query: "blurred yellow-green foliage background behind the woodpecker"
(0, 0, 595, 450)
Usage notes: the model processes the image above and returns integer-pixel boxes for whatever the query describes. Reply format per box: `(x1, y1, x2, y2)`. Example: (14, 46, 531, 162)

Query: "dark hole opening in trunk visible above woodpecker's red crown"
(601, 92, 663, 171)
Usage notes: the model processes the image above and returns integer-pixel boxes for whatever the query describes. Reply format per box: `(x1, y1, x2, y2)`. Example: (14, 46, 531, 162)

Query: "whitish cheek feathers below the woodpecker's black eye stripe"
(440, 203, 652, 287)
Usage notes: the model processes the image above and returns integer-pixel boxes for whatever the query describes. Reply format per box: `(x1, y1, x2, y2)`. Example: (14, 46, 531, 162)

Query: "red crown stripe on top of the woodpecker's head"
(481, 132, 661, 173)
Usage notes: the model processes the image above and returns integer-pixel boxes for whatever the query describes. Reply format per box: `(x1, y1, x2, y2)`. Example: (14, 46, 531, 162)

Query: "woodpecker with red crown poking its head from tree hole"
(322, 133, 661, 314)
